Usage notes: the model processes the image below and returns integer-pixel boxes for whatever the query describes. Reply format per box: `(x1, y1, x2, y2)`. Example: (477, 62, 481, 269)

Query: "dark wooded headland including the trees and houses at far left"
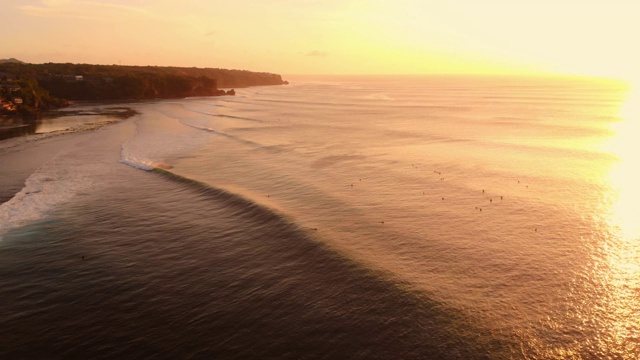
(0, 58, 287, 115)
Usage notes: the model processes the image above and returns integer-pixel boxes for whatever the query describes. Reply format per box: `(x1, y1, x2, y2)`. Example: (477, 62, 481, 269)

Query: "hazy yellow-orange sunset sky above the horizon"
(0, 0, 640, 79)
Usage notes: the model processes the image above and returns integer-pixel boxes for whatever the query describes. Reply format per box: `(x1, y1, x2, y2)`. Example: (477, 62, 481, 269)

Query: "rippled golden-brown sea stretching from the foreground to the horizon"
(0, 76, 640, 359)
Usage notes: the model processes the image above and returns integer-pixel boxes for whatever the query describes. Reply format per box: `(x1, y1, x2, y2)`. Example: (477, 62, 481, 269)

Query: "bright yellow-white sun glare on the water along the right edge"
(599, 83, 640, 356)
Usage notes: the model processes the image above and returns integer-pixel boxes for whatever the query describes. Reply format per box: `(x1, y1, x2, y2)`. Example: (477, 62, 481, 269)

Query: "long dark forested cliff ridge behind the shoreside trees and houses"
(0, 62, 284, 100)
